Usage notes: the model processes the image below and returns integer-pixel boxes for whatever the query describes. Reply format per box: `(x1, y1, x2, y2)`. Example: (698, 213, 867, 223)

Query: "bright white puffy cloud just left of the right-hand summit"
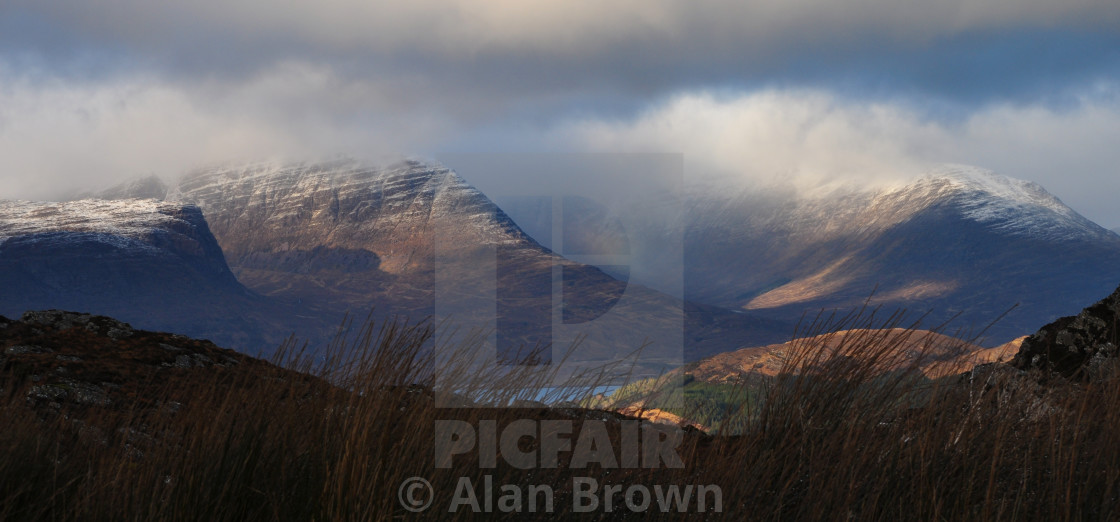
(563, 91, 926, 189)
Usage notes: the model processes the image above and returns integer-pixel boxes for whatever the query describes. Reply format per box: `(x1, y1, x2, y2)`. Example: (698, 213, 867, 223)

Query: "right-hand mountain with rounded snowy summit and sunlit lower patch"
(685, 166, 1120, 343)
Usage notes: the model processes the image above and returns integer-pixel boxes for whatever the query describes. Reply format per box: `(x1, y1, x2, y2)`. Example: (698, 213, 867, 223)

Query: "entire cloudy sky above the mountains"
(0, 0, 1120, 227)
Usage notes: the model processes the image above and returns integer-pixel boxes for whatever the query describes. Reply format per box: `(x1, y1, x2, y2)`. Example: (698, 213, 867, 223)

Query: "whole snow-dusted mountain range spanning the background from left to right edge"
(0, 156, 1120, 376)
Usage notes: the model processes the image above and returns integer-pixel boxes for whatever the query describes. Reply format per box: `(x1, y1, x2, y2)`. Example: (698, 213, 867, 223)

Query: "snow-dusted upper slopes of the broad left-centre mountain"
(168, 159, 526, 255)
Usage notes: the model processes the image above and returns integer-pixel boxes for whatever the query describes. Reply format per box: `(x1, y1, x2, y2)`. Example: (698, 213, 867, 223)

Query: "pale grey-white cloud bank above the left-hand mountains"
(0, 64, 445, 198)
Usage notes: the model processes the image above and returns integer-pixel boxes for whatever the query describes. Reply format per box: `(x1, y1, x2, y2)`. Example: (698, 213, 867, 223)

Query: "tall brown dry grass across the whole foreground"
(0, 306, 1120, 521)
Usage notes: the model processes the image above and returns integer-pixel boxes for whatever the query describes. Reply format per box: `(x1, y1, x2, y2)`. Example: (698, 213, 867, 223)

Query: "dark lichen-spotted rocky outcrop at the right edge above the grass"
(1012, 283, 1120, 377)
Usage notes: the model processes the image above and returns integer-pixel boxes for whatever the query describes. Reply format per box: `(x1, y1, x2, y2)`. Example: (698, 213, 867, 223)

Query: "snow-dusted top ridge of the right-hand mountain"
(689, 165, 1117, 242)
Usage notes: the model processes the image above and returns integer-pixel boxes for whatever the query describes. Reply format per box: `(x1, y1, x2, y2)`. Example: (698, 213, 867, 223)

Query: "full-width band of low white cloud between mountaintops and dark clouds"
(0, 62, 1120, 226)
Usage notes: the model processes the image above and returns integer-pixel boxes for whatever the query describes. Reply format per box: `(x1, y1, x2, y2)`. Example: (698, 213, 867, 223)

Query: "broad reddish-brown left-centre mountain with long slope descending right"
(102, 160, 792, 372)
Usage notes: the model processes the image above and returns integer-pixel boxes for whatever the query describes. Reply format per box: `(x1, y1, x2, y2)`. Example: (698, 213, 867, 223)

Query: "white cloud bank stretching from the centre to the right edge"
(552, 88, 1120, 226)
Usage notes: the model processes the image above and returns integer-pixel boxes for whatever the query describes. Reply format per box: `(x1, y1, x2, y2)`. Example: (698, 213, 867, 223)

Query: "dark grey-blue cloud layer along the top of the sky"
(8, 0, 1120, 110)
